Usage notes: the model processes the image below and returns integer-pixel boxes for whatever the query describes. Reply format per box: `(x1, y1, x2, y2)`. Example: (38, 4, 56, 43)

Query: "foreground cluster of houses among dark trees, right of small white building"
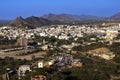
(48, 53, 82, 70)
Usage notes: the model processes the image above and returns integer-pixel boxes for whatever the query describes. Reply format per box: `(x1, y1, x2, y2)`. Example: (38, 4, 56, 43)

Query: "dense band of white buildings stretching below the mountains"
(0, 25, 120, 40)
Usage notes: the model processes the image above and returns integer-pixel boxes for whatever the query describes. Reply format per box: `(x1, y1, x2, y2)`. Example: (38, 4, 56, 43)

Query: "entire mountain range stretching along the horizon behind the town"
(0, 12, 120, 28)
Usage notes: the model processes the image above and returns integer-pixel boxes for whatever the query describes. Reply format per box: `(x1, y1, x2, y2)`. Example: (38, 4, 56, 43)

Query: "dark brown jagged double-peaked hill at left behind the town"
(8, 16, 51, 28)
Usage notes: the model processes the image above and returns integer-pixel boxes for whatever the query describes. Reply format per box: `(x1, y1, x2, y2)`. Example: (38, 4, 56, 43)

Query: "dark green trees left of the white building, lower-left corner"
(0, 57, 30, 80)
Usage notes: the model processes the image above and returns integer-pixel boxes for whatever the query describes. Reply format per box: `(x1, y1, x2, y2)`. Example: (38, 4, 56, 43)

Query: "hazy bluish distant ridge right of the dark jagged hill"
(42, 14, 104, 21)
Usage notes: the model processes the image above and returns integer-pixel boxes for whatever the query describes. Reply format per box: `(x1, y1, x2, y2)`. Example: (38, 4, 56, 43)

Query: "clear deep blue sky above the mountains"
(0, 0, 120, 20)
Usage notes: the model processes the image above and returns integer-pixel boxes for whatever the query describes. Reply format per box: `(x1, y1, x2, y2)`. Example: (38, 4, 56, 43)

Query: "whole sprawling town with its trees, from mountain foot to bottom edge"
(0, 23, 120, 80)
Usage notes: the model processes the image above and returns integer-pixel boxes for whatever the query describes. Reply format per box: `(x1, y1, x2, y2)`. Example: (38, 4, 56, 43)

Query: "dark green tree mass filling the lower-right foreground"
(52, 58, 120, 80)
